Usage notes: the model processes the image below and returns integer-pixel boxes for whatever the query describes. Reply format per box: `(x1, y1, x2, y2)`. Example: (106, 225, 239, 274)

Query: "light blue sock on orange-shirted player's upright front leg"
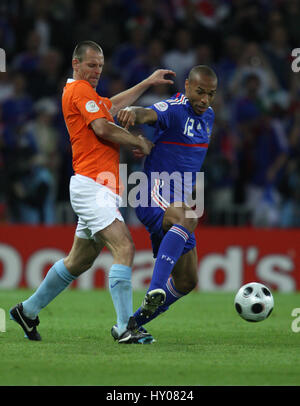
(108, 264, 133, 336)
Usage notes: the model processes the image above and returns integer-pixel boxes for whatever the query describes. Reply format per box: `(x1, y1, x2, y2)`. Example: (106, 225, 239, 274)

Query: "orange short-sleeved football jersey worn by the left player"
(62, 79, 120, 194)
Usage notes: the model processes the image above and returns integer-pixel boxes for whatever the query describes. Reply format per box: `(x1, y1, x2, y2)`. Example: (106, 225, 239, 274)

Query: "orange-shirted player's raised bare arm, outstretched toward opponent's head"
(110, 69, 176, 116)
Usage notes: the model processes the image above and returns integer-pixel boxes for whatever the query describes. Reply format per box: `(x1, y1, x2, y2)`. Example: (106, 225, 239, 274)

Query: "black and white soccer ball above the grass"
(234, 282, 274, 322)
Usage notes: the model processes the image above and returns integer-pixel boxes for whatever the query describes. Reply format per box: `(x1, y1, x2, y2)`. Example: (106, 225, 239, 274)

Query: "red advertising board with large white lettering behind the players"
(0, 225, 300, 292)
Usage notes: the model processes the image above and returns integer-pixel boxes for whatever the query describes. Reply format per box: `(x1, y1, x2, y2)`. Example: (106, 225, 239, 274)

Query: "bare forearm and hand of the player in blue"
(117, 106, 157, 129)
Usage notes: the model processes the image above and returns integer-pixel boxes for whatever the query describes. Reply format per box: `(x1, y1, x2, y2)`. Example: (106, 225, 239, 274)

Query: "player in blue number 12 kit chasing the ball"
(112, 65, 218, 338)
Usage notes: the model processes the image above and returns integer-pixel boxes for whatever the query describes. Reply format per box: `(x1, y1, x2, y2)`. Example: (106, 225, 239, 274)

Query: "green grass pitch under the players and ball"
(0, 289, 300, 386)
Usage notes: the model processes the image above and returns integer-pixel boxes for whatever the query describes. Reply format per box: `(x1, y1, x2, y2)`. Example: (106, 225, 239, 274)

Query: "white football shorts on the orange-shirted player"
(70, 175, 124, 239)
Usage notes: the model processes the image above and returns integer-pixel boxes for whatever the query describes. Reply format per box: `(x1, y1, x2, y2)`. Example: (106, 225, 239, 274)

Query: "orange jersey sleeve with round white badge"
(73, 83, 112, 126)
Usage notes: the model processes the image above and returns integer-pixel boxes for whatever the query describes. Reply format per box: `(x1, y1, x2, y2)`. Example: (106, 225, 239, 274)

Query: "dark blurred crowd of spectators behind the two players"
(0, 0, 300, 227)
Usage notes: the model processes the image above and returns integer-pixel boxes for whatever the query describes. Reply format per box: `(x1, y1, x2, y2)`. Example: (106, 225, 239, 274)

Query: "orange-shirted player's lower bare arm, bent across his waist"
(90, 118, 154, 155)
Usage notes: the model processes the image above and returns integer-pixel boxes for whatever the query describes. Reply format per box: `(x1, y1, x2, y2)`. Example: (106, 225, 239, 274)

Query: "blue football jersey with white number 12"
(144, 93, 214, 202)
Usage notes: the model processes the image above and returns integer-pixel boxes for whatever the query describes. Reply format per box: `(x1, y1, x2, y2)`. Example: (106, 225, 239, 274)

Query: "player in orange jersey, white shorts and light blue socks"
(10, 41, 175, 344)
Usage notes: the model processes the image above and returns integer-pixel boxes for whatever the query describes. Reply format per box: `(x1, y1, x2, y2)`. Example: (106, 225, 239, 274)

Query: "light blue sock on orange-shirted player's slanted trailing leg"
(22, 259, 77, 319)
